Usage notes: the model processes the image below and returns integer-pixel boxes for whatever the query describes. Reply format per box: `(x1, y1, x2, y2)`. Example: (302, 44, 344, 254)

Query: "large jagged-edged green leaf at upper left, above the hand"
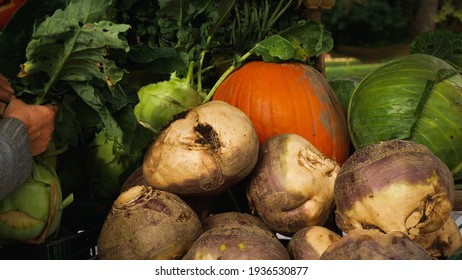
(18, 0, 129, 139)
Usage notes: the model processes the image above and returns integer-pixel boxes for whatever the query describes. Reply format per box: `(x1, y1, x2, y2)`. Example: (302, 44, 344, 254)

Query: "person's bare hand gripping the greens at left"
(3, 95, 58, 156)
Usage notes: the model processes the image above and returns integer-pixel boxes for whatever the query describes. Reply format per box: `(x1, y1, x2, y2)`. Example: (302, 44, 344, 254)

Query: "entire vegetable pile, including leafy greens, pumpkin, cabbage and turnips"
(0, 0, 462, 260)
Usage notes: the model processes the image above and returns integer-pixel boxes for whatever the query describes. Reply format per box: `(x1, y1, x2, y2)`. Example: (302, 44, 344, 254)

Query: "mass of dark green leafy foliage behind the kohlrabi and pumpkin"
(0, 0, 333, 201)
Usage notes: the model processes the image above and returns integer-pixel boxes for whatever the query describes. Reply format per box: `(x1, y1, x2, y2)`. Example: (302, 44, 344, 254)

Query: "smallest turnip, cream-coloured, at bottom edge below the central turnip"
(287, 226, 342, 260)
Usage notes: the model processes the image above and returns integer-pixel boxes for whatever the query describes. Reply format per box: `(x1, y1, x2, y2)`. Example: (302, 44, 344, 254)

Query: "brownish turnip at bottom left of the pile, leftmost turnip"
(97, 185, 202, 260)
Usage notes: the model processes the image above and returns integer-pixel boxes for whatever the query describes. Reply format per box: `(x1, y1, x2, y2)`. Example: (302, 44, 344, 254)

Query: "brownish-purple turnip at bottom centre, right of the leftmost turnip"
(183, 212, 289, 260)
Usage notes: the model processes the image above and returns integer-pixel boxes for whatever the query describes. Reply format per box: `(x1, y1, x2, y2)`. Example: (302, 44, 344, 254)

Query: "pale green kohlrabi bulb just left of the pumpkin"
(134, 74, 204, 134)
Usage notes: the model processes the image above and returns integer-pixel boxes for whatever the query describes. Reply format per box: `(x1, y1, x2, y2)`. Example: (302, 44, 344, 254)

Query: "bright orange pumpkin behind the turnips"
(212, 61, 350, 164)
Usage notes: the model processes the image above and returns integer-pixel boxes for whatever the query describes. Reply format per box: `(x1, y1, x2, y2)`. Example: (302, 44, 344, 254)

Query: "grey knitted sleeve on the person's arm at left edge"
(0, 118, 32, 200)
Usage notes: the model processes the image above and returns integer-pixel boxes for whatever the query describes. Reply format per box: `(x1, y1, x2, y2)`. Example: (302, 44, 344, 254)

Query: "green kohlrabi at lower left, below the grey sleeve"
(0, 163, 73, 243)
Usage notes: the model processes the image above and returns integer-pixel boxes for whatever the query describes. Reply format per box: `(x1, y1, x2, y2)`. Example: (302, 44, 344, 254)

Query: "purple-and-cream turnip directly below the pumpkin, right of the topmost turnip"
(247, 134, 340, 235)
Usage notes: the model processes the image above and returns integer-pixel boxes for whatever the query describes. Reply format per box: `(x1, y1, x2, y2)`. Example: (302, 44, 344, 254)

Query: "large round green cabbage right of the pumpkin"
(347, 54, 462, 179)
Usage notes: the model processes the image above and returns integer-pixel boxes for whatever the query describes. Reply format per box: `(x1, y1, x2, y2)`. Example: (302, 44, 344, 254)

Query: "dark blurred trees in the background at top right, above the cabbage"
(322, 0, 462, 47)
